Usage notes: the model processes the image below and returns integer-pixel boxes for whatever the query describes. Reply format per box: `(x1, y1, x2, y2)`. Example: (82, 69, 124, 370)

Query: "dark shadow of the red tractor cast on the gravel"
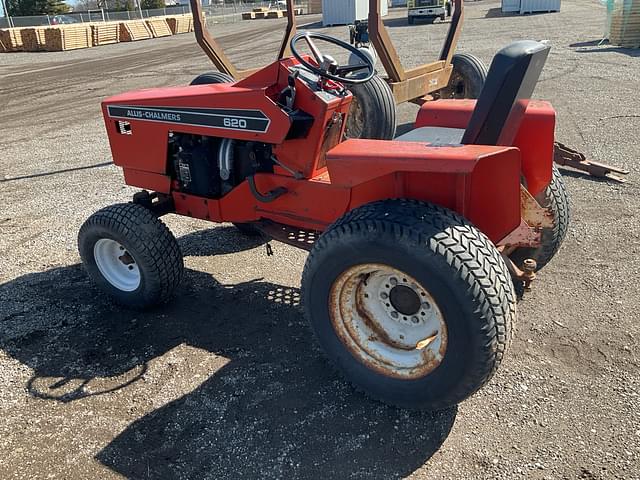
(0, 228, 457, 479)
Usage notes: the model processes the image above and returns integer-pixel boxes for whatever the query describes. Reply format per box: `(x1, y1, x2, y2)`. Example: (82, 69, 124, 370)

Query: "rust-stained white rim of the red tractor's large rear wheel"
(329, 264, 447, 379)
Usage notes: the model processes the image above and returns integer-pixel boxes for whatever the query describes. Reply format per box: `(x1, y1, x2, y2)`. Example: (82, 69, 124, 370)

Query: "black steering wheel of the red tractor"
(291, 32, 376, 85)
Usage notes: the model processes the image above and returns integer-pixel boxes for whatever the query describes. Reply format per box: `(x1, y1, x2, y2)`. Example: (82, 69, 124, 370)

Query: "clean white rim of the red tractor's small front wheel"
(93, 238, 141, 292)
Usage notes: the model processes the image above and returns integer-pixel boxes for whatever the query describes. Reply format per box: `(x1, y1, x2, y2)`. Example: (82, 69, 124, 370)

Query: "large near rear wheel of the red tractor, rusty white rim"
(302, 200, 516, 410)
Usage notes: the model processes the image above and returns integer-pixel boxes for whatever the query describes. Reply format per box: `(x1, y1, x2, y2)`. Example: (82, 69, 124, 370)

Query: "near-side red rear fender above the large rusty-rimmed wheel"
(327, 139, 520, 242)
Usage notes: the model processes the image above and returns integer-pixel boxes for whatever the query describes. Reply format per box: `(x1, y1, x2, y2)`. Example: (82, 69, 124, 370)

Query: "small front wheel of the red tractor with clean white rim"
(78, 203, 184, 309)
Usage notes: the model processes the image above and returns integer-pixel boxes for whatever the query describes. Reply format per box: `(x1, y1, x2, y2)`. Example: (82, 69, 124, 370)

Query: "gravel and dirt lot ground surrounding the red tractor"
(0, 0, 640, 479)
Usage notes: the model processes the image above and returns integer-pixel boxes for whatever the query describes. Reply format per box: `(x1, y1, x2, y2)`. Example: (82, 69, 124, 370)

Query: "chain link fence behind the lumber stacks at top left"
(0, 0, 309, 28)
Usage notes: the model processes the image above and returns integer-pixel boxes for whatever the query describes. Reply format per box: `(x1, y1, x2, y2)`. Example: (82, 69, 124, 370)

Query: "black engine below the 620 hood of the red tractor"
(168, 132, 274, 199)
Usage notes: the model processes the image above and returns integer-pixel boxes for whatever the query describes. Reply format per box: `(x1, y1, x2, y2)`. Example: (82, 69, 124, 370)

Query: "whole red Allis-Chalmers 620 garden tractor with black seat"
(79, 4, 568, 409)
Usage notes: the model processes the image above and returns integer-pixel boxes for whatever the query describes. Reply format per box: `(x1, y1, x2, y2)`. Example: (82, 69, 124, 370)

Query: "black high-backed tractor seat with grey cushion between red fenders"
(395, 40, 550, 146)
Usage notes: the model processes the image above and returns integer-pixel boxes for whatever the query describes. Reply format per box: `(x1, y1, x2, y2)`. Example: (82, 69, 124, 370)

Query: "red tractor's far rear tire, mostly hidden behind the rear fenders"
(511, 165, 571, 270)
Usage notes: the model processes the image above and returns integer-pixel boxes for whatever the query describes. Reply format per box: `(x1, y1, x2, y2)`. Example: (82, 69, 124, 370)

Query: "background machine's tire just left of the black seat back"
(438, 53, 487, 99)
